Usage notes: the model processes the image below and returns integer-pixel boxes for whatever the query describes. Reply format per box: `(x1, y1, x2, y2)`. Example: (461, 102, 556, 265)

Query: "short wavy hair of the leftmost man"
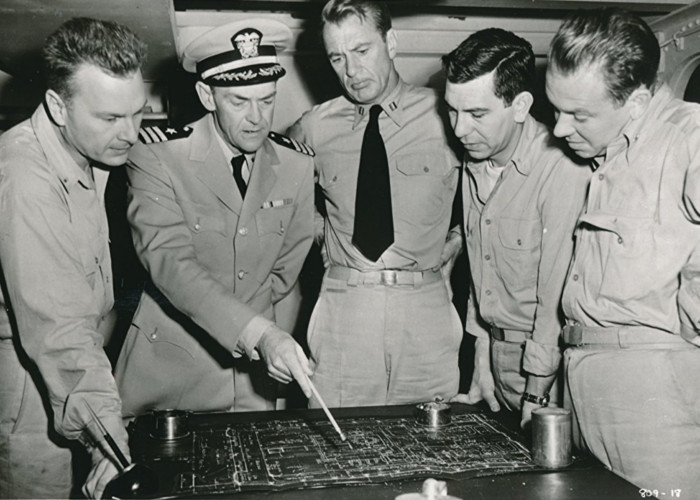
(42, 17, 146, 100)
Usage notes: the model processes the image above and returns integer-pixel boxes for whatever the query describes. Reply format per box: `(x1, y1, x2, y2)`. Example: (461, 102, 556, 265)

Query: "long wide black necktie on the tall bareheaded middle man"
(352, 104, 394, 261)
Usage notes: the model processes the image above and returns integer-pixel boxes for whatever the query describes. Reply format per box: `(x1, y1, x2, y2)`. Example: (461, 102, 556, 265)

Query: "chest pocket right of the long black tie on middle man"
(391, 151, 457, 226)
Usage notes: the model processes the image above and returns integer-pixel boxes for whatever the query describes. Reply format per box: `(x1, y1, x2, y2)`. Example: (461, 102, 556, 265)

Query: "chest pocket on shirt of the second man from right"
(496, 217, 542, 289)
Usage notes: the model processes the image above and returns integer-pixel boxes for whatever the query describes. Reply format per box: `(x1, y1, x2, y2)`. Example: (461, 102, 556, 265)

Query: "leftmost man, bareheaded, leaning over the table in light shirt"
(0, 18, 146, 498)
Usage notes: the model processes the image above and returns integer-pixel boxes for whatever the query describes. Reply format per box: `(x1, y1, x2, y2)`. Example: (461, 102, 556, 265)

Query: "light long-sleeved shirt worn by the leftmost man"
(0, 106, 128, 450)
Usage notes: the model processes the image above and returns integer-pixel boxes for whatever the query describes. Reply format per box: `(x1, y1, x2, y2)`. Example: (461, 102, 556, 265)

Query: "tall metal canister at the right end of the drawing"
(532, 408, 573, 469)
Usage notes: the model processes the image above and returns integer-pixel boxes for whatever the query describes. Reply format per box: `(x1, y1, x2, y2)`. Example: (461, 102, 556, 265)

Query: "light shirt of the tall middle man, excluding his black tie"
(289, 81, 460, 271)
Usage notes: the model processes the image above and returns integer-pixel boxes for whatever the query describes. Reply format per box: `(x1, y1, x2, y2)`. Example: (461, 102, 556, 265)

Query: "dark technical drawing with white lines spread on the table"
(174, 414, 537, 496)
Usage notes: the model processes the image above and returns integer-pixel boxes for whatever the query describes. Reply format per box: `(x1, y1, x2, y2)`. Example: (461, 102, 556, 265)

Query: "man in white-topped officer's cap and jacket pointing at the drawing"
(116, 19, 313, 416)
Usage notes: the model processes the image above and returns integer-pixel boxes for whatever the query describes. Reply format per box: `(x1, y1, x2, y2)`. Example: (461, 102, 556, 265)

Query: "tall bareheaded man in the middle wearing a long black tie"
(291, 0, 462, 406)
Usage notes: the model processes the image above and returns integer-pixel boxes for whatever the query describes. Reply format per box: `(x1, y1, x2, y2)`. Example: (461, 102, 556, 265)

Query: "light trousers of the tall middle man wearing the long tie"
(308, 271, 462, 407)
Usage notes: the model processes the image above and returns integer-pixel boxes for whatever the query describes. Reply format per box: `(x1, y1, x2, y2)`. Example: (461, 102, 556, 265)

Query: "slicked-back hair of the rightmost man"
(548, 8, 661, 105)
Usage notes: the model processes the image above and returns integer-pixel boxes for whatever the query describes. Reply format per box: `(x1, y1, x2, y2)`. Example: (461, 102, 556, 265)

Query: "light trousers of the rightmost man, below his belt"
(564, 344, 700, 498)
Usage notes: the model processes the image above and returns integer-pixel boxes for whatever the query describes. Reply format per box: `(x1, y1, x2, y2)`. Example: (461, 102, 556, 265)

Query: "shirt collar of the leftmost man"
(31, 104, 95, 192)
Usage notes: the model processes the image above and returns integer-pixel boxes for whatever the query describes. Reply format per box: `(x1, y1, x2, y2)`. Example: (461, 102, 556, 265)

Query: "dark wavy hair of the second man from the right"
(442, 28, 535, 106)
